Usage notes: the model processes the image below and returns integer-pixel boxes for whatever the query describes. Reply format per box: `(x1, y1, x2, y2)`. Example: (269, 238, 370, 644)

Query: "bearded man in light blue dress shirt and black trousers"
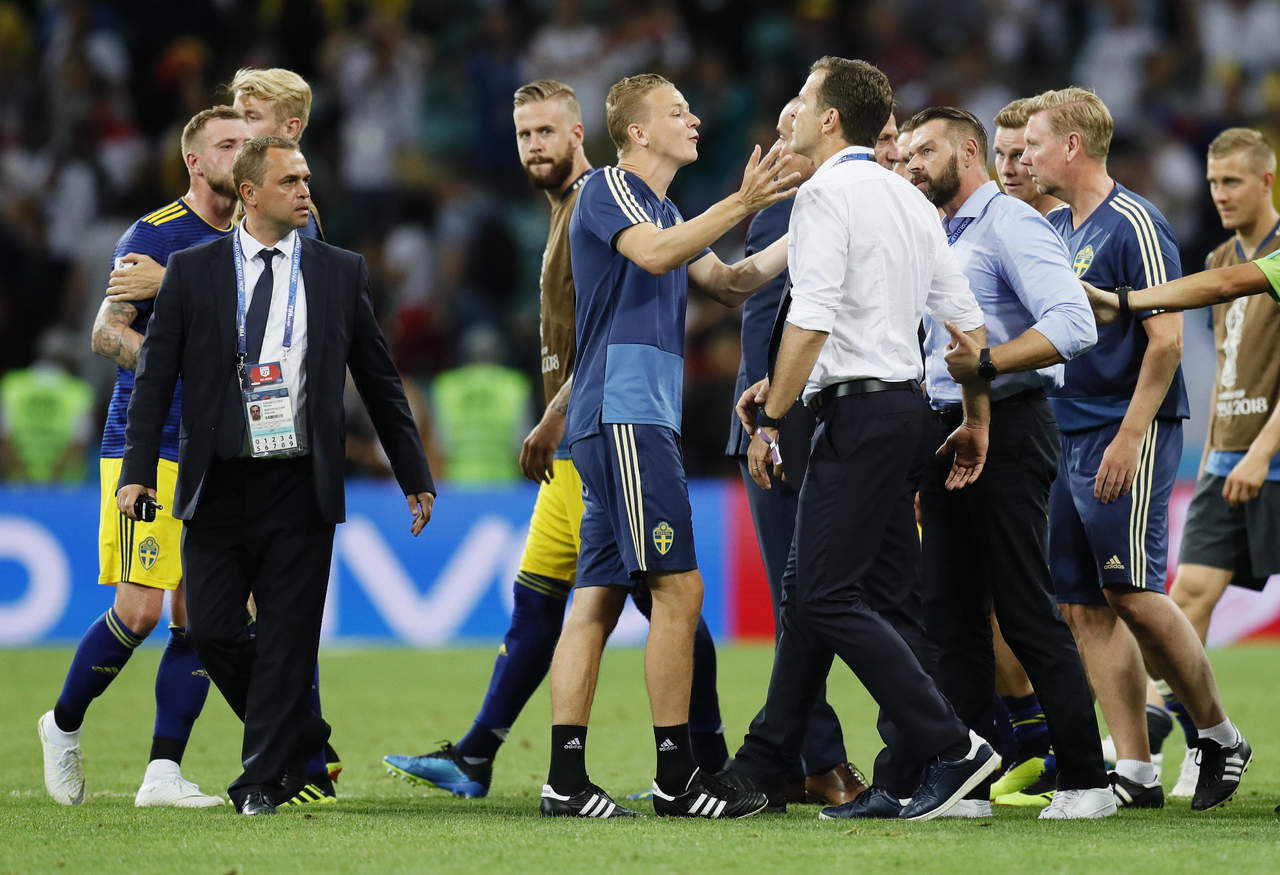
(906, 107, 1115, 819)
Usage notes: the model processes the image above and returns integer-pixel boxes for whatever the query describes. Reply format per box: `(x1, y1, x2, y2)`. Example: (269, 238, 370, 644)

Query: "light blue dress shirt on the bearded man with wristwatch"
(924, 182, 1098, 409)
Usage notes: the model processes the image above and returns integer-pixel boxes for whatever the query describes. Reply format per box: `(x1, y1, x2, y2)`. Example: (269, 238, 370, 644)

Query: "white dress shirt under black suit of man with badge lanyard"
(236, 223, 307, 419)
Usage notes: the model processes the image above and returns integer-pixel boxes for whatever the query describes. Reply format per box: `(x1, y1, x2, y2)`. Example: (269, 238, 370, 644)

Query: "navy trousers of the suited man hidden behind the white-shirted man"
(739, 455, 849, 780)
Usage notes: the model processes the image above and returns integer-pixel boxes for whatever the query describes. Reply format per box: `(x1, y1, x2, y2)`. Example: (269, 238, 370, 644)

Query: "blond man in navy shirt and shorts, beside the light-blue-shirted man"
(1023, 88, 1252, 811)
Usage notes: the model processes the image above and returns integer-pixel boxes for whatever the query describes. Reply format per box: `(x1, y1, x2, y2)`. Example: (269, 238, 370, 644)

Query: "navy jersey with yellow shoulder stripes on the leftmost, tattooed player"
(101, 198, 232, 462)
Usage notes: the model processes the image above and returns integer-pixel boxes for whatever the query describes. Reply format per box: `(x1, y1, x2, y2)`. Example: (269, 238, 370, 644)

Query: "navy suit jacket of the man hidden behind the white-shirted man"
(724, 197, 795, 455)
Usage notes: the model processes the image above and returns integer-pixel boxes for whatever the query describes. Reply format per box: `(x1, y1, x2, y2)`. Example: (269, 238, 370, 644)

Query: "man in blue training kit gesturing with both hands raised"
(541, 74, 797, 817)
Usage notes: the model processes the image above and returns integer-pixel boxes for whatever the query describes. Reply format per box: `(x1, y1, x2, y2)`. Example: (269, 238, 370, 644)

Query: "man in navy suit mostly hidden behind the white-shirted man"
(724, 100, 865, 805)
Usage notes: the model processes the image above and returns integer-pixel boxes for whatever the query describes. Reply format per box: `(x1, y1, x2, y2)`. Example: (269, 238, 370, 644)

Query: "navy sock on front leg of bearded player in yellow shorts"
(457, 572, 570, 762)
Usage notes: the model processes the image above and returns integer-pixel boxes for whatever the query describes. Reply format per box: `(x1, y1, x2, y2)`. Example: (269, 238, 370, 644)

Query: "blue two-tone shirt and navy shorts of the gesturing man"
(566, 166, 710, 587)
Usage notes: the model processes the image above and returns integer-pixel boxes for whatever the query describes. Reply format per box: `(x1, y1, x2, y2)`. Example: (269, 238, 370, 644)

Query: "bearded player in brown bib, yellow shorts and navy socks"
(383, 79, 728, 798)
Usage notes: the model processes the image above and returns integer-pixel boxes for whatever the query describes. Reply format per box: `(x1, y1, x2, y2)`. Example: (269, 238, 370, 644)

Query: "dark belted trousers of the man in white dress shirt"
(736, 391, 968, 796)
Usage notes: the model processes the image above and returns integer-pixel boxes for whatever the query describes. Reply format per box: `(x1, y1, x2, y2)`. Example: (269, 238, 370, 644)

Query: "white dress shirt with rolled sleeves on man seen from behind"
(787, 146, 983, 402)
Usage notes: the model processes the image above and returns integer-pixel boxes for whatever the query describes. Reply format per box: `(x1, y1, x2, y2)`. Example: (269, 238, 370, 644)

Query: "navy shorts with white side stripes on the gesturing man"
(572, 422, 698, 588)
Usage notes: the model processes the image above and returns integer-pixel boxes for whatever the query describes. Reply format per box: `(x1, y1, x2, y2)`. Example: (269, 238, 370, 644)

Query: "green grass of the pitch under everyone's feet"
(0, 646, 1280, 875)
